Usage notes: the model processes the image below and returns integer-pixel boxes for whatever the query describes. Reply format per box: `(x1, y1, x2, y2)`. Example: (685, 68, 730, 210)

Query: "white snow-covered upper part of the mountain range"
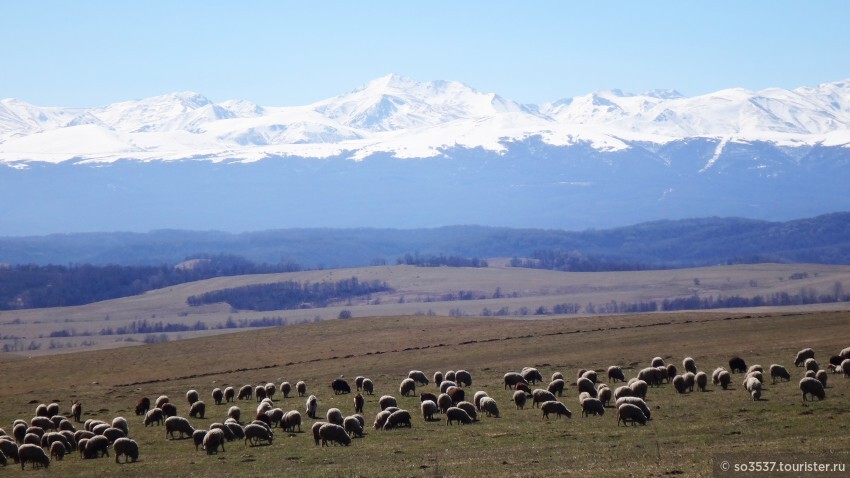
(0, 75, 850, 165)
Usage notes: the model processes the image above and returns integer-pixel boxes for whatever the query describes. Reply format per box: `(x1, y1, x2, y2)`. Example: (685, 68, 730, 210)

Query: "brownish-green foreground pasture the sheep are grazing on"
(0, 311, 850, 477)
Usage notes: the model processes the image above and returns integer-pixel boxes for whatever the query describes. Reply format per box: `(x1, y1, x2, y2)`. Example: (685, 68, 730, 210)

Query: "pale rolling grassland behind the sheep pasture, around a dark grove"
(0, 260, 850, 356)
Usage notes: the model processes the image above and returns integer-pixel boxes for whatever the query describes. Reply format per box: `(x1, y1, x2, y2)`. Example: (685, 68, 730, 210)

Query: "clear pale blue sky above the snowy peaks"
(0, 0, 850, 107)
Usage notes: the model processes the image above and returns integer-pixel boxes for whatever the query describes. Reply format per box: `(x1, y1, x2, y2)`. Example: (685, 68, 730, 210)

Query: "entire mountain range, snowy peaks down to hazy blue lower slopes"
(0, 75, 850, 236)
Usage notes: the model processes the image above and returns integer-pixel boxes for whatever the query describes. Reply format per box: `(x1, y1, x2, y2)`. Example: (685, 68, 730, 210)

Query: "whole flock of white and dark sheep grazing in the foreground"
(0, 347, 850, 469)
